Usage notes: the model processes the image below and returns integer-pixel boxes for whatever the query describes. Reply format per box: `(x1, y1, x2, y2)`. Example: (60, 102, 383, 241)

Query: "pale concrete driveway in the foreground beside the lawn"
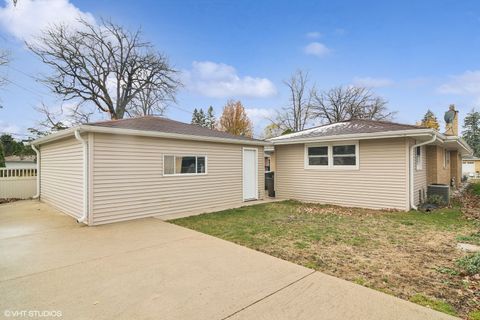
(0, 201, 455, 320)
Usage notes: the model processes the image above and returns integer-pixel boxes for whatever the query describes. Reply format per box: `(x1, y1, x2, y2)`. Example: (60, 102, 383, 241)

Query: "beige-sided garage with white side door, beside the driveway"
(32, 117, 268, 225)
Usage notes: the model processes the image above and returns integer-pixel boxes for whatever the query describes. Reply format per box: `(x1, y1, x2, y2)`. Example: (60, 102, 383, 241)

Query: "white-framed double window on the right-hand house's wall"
(305, 141, 359, 169)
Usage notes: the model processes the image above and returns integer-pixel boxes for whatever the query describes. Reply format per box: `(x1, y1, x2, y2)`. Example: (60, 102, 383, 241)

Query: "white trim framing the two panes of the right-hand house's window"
(304, 140, 360, 171)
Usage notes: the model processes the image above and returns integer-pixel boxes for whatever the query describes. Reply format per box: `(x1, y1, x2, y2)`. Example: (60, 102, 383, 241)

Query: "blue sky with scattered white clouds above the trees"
(0, 0, 480, 138)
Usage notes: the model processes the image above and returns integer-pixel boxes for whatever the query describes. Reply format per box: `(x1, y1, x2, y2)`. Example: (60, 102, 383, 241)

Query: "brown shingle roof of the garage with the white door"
(88, 116, 261, 142)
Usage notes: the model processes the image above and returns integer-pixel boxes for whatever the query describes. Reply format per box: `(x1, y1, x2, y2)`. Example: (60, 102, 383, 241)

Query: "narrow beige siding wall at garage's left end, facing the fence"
(40, 137, 83, 218)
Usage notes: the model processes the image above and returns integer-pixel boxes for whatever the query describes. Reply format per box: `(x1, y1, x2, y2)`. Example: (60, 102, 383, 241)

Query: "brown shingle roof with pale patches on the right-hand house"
(271, 120, 428, 141)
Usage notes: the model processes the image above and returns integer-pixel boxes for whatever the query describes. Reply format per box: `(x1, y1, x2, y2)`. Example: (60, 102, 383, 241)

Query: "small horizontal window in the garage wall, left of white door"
(163, 155, 207, 175)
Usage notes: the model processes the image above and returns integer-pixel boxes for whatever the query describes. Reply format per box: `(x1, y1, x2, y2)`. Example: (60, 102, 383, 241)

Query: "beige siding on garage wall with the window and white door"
(91, 133, 264, 224)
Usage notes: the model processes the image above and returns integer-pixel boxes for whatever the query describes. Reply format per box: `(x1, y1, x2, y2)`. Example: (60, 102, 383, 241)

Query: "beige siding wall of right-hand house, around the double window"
(275, 138, 408, 210)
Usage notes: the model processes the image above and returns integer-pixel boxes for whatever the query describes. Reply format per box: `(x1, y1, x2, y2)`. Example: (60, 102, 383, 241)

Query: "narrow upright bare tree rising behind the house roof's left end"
(273, 70, 315, 132)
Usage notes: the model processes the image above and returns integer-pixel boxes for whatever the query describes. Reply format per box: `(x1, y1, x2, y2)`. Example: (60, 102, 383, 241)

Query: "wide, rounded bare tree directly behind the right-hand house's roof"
(311, 87, 395, 123)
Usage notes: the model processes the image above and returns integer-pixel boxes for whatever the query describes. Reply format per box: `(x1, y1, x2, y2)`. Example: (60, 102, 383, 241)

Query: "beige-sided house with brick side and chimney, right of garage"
(269, 112, 472, 210)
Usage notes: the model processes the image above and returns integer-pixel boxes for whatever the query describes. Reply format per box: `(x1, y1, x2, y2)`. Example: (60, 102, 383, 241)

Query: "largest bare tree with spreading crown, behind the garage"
(27, 20, 180, 119)
